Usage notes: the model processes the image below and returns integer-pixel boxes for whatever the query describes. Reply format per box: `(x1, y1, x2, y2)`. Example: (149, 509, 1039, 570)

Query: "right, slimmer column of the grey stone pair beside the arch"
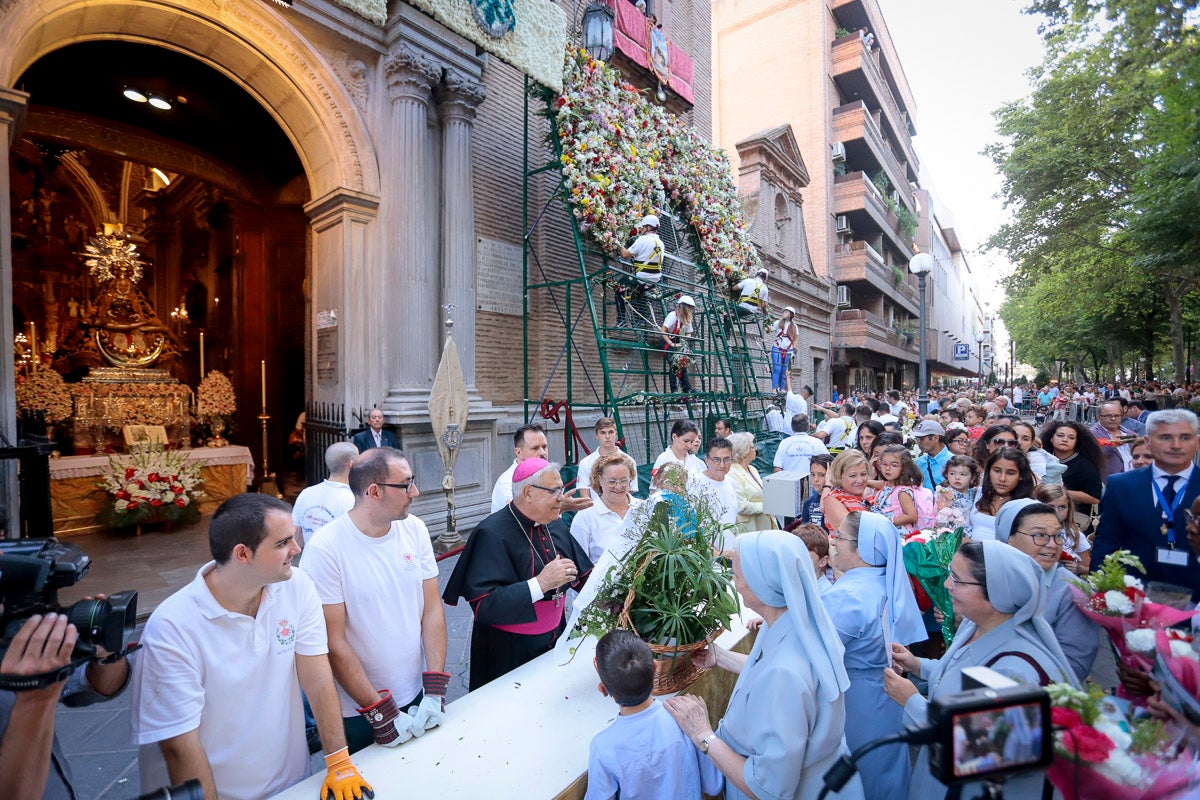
(438, 72, 487, 393)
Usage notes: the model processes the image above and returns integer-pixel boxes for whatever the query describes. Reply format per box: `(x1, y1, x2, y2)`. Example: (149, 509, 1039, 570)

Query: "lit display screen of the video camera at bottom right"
(954, 703, 1043, 778)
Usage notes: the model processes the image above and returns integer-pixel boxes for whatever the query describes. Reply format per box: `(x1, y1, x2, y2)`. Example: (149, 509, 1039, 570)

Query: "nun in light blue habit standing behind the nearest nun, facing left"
(823, 511, 926, 800)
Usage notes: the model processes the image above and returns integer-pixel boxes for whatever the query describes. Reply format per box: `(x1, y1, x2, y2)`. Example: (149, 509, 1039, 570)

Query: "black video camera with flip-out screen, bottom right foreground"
(821, 667, 1054, 798)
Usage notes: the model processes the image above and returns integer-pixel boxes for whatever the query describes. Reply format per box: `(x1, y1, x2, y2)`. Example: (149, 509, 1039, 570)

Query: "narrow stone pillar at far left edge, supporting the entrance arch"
(0, 89, 29, 539)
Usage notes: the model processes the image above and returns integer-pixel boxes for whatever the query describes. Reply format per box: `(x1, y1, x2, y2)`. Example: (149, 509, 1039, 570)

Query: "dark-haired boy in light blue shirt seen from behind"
(584, 631, 725, 800)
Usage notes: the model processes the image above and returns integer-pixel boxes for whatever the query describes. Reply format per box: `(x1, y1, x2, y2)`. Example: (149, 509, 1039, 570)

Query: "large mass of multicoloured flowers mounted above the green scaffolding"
(548, 48, 761, 285)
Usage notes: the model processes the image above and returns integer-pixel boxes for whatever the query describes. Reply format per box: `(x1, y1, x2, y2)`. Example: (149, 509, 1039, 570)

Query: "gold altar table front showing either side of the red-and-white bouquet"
(50, 445, 254, 536)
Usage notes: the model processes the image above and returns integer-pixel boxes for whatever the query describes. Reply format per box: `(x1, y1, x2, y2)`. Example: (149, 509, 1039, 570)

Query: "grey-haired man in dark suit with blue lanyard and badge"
(1092, 409, 1200, 600)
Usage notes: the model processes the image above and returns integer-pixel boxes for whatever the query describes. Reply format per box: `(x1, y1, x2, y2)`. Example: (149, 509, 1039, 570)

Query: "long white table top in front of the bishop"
(276, 609, 755, 800)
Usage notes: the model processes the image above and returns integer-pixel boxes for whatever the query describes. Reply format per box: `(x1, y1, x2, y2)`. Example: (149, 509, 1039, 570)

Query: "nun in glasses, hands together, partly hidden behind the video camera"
(883, 541, 1079, 800)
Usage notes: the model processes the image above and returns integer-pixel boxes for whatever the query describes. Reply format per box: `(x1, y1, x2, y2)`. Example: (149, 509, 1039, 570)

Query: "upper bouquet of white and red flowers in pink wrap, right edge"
(1072, 551, 1196, 694)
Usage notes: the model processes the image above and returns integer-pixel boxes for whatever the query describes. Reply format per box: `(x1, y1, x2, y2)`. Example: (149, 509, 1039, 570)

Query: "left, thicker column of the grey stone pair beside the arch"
(379, 44, 442, 415)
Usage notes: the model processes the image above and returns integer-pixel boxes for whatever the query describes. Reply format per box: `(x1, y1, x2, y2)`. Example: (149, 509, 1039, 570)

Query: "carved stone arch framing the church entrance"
(0, 0, 380, 519)
